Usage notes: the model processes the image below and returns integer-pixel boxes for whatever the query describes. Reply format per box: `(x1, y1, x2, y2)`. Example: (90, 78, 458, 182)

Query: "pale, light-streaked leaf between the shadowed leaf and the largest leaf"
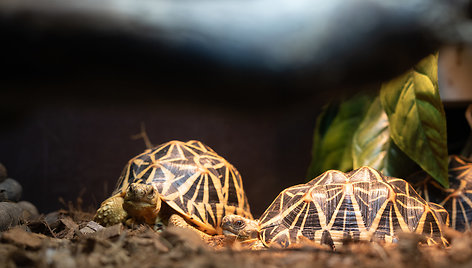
(352, 97, 417, 178)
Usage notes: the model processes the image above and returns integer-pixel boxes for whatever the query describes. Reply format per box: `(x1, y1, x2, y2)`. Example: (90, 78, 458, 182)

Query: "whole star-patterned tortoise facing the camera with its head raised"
(94, 140, 252, 236)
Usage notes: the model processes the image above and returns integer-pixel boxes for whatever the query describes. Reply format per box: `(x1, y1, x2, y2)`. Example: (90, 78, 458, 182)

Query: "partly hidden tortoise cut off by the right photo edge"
(412, 155, 472, 231)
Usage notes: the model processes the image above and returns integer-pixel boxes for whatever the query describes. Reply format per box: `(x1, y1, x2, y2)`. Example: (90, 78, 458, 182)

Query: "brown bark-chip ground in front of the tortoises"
(0, 209, 472, 268)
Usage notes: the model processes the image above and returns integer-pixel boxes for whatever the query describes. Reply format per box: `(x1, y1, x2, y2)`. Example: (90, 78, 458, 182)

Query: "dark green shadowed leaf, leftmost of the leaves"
(307, 95, 372, 179)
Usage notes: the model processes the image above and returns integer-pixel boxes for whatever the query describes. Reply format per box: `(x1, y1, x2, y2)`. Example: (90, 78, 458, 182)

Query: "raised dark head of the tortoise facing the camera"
(123, 183, 162, 224)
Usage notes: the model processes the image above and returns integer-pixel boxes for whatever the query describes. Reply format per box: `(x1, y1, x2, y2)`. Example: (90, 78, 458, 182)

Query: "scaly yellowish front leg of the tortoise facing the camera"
(93, 193, 128, 226)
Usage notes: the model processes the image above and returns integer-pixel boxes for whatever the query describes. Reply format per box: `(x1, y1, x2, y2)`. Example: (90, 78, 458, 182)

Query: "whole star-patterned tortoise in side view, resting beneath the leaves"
(223, 167, 448, 249)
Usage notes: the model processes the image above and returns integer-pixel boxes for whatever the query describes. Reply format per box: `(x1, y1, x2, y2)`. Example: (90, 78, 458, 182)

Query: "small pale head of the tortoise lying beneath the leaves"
(221, 215, 259, 240)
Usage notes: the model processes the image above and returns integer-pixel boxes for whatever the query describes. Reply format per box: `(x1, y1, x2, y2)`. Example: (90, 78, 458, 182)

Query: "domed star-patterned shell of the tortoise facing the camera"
(114, 140, 252, 234)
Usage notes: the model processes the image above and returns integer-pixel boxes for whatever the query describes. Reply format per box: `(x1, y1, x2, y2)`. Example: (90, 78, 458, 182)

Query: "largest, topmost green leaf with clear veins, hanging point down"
(380, 55, 449, 187)
